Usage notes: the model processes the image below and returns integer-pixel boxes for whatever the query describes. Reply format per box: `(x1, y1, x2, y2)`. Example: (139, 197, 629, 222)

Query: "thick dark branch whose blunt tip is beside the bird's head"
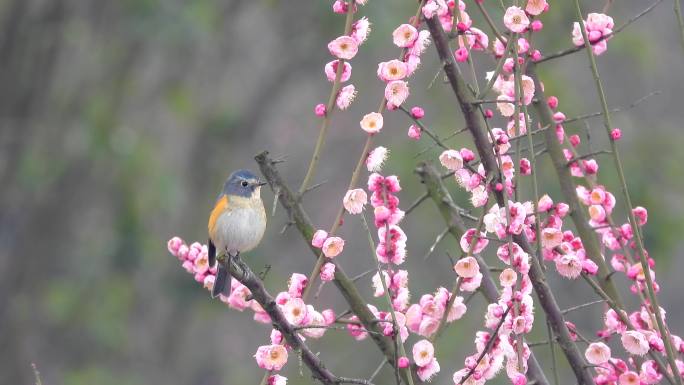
(255, 151, 406, 382)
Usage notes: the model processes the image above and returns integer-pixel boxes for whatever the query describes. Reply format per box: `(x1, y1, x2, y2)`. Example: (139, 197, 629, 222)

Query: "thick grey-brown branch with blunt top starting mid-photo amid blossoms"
(416, 163, 549, 385)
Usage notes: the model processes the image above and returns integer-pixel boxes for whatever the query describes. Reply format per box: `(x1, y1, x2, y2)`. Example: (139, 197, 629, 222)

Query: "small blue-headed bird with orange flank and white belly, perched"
(207, 170, 267, 298)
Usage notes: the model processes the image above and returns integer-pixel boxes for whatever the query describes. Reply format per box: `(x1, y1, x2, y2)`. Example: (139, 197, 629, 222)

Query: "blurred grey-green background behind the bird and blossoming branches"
(0, 0, 684, 385)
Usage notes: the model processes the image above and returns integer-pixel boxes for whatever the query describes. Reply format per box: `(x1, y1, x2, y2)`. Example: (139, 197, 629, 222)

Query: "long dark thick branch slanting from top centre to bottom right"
(427, 18, 594, 385)
